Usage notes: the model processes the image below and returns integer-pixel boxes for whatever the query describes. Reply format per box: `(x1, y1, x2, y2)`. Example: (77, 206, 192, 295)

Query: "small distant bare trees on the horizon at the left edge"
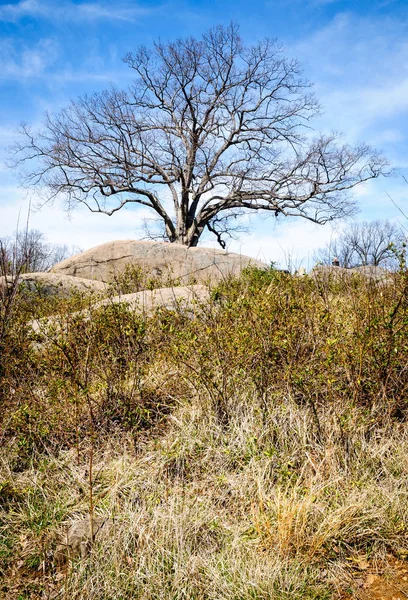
(0, 229, 70, 275)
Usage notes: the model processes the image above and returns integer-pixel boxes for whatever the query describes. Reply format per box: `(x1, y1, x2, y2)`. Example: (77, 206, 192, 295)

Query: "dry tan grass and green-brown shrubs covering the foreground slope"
(0, 266, 408, 600)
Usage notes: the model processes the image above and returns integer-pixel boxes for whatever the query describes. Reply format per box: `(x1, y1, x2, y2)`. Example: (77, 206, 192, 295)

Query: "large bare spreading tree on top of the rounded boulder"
(16, 24, 385, 246)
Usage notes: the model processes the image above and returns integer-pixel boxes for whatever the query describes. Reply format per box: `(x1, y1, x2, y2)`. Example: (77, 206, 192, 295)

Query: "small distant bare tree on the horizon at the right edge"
(317, 220, 406, 268)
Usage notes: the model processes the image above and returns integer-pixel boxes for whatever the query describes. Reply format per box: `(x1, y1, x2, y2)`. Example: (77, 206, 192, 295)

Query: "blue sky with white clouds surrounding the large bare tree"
(0, 0, 408, 266)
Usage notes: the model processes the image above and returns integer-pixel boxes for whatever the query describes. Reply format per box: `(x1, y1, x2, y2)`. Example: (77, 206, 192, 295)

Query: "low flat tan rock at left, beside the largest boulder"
(0, 273, 108, 297)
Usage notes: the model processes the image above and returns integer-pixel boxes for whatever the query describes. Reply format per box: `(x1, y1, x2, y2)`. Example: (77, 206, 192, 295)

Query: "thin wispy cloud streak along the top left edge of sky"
(0, 0, 152, 22)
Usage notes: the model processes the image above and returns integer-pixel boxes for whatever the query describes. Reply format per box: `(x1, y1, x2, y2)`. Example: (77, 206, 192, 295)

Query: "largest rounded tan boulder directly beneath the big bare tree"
(51, 240, 267, 284)
